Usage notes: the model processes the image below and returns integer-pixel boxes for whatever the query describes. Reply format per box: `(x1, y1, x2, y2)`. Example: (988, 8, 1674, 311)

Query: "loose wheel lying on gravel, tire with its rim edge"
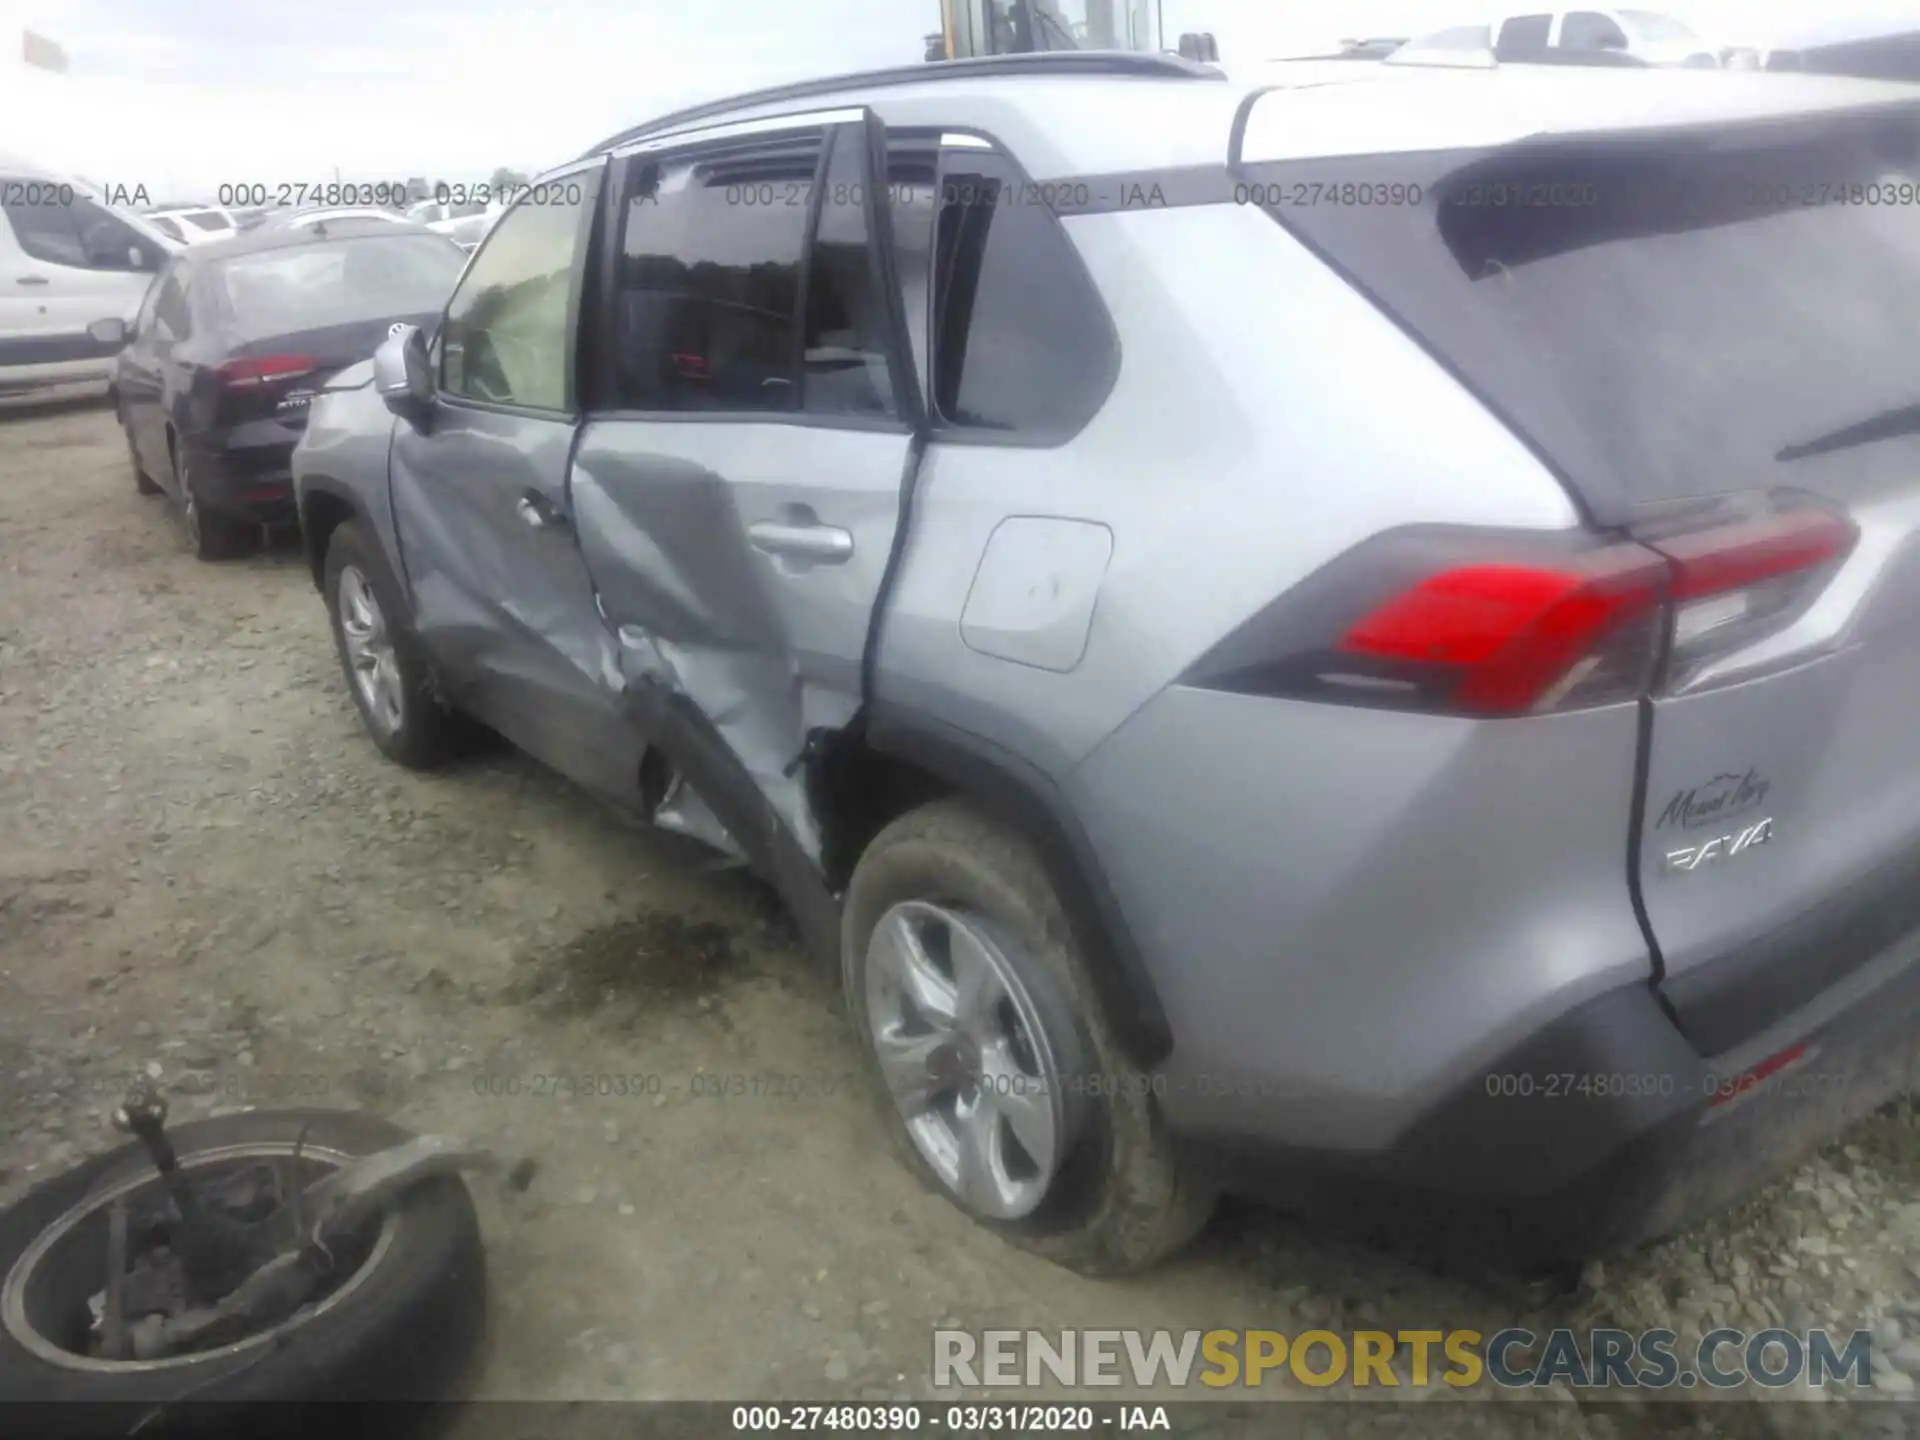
(0, 1110, 486, 1436)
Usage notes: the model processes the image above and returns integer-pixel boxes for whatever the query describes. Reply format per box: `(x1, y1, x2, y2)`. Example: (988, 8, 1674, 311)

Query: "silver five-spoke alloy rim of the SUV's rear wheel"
(866, 900, 1073, 1219)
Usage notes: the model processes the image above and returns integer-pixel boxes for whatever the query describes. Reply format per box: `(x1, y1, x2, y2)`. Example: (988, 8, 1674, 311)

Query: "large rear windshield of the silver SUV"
(1246, 108, 1920, 522)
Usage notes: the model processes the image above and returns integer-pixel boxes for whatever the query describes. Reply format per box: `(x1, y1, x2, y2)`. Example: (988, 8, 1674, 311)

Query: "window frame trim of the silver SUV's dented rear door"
(584, 106, 914, 436)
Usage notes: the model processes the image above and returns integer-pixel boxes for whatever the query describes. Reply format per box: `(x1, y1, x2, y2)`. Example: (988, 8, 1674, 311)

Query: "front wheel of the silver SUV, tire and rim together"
(324, 520, 455, 770)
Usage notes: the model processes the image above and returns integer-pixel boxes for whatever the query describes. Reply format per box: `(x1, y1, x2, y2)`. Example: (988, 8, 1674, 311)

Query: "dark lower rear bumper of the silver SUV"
(1200, 952, 1920, 1263)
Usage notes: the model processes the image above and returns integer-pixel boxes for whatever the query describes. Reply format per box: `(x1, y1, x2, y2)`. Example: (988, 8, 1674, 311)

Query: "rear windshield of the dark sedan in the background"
(215, 234, 467, 336)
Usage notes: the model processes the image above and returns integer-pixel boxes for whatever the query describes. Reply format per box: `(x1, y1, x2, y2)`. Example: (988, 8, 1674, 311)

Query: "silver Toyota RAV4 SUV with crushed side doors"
(294, 54, 1920, 1273)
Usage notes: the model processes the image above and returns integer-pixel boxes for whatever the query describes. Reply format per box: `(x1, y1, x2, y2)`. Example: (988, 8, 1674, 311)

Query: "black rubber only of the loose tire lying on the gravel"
(0, 1110, 486, 1434)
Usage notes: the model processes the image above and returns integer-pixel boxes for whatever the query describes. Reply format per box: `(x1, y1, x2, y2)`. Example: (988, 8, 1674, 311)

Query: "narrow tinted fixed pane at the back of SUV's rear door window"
(801, 125, 895, 415)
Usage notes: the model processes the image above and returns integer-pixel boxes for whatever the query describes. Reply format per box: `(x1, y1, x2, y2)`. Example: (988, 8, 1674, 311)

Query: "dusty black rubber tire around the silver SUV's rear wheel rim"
(841, 801, 1215, 1275)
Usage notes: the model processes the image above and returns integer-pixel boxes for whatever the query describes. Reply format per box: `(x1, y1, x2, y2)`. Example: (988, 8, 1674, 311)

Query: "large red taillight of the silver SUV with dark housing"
(1188, 497, 1857, 716)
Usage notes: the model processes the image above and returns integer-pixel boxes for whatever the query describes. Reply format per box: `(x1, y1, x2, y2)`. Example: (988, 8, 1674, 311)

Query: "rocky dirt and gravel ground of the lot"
(0, 405, 1920, 1436)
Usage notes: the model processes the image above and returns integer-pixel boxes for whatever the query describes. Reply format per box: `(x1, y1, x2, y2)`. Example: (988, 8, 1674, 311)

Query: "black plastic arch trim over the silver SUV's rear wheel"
(866, 701, 1173, 1068)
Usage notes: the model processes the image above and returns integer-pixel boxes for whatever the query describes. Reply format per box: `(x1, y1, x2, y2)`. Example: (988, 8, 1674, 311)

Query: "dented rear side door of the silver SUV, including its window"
(572, 109, 918, 858)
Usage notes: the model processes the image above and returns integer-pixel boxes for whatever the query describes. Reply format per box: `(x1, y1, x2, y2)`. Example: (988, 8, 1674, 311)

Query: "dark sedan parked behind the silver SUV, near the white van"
(92, 219, 467, 561)
